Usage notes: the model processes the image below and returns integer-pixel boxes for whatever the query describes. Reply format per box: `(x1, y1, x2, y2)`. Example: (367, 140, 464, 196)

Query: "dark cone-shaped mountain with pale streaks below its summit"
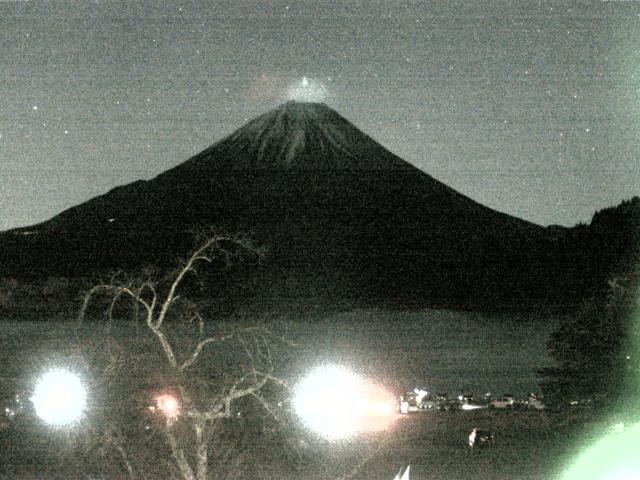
(0, 102, 636, 308)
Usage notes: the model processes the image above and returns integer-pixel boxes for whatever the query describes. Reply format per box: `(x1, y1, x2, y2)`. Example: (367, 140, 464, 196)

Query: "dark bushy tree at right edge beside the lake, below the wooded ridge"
(540, 277, 640, 407)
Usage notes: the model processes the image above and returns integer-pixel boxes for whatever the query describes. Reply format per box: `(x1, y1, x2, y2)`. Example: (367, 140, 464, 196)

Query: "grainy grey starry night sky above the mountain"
(0, 0, 640, 230)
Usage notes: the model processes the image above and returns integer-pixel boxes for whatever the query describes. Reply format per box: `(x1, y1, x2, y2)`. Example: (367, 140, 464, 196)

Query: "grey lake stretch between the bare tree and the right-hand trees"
(284, 310, 560, 396)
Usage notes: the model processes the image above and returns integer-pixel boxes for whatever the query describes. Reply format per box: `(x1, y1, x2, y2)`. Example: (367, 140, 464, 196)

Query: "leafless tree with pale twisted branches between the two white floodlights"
(79, 235, 287, 480)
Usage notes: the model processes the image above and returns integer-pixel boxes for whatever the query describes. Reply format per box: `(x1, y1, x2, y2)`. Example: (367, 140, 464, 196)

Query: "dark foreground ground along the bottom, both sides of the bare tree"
(0, 404, 607, 480)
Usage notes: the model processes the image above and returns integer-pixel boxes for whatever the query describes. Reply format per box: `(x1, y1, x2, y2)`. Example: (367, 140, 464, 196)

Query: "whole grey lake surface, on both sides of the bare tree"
(0, 309, 560, 397)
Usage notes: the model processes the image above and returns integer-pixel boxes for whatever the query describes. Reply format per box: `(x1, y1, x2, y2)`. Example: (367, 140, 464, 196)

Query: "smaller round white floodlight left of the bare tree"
(31, 369, 87, 426)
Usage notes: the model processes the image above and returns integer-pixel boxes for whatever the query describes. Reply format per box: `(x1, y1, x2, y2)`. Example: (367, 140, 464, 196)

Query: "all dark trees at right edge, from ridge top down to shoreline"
(540, 197, 640, 411)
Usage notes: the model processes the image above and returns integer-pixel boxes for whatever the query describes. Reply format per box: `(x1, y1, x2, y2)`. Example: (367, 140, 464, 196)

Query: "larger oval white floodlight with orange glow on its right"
(294, 365, 394, 440)
